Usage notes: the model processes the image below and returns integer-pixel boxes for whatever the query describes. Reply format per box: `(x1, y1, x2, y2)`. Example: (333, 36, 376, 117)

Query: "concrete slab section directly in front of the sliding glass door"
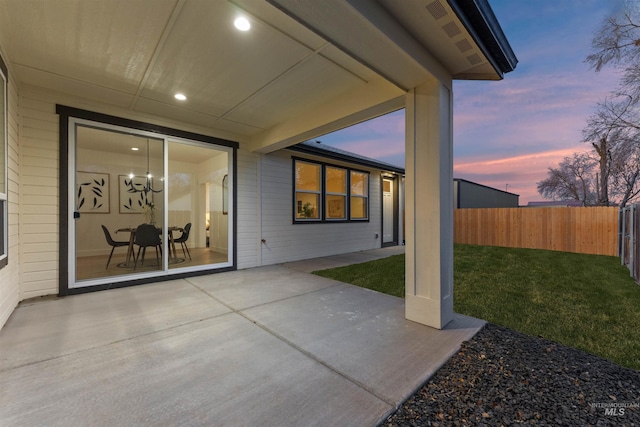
(0, 280, 231, 372)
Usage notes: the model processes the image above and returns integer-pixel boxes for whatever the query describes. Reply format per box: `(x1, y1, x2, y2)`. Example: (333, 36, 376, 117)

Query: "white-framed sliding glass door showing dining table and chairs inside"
(69, 119, 233, 289)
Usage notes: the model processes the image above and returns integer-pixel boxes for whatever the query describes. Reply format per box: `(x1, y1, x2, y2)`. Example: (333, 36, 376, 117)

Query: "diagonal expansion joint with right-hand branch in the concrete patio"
(186, 280, 398, 411)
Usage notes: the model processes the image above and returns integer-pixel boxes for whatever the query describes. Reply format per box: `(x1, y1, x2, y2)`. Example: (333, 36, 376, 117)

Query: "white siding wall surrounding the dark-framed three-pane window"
(260, 151, 382, 265)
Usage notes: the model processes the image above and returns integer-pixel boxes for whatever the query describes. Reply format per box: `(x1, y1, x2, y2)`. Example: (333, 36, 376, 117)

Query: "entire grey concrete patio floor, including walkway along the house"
(0, 248, 484, 426)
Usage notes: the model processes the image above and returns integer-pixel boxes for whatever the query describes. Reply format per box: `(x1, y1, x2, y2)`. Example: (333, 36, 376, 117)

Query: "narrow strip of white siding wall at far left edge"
(0, 56, 20, 328)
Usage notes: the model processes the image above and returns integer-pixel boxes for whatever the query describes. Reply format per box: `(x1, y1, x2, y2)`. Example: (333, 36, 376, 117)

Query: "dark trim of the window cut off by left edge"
(0, 51, 9, 269)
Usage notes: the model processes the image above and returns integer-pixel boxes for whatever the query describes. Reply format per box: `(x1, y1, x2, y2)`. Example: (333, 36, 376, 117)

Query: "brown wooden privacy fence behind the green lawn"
(454, 207, 618, 256)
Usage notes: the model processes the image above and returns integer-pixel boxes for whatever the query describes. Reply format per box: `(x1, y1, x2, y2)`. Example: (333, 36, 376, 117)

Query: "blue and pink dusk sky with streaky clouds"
(318, 0, 623, 205)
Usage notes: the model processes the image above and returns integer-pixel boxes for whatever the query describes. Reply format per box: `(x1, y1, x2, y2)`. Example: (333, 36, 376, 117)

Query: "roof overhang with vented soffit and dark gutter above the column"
(268, 0, 517, 90)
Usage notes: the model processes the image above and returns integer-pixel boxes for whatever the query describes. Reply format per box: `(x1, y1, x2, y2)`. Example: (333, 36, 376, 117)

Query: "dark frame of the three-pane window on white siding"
(291, 156, 371, 224)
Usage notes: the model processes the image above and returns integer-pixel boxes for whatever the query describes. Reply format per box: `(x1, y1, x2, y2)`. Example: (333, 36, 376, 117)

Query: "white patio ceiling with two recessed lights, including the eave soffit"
(0, 0, 499, 149)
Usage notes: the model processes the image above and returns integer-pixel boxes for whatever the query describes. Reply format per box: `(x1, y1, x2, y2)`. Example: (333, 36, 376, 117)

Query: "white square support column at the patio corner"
(405, 79, 453, 329)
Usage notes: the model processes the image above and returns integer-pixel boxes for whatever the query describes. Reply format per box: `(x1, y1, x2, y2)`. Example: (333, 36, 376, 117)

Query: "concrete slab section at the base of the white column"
(244, 285, 485, 406)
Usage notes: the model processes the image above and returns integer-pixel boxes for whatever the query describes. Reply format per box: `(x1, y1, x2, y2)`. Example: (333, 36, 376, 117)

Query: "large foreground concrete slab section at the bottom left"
(0, 314, 390, 426)
